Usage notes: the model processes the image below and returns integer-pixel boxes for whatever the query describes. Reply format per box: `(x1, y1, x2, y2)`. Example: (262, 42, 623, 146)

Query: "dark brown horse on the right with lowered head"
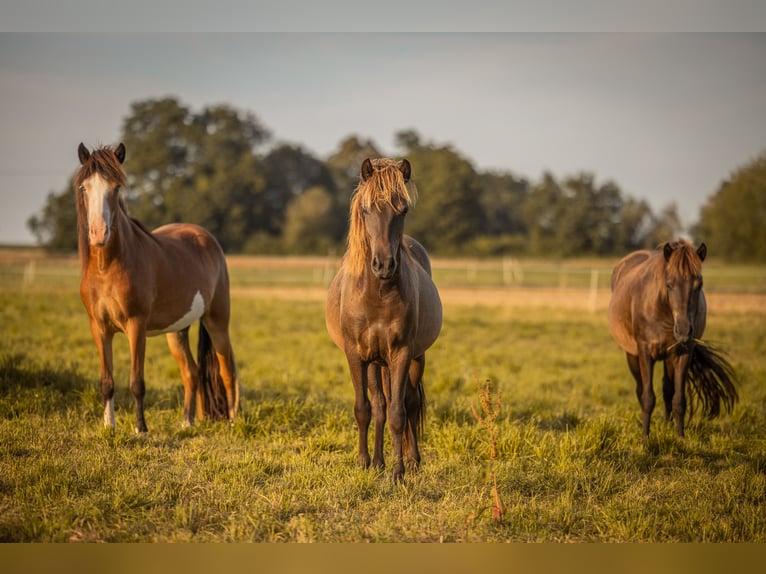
(609, 239, 738, 437)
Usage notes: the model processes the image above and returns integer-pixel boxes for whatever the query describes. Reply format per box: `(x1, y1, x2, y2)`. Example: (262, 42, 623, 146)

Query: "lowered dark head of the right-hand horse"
(663, 240, 707, 344)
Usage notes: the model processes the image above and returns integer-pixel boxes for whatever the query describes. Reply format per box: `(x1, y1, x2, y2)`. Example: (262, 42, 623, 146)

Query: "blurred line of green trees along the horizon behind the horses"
(27, 97, 766, 261)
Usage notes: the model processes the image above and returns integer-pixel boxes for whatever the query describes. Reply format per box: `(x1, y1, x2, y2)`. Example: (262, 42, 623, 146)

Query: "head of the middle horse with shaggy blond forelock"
(349, 158, 417, 280)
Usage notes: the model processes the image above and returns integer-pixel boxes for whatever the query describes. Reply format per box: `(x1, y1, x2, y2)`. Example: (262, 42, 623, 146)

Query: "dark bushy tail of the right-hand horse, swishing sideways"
(688, 342, 739, 424)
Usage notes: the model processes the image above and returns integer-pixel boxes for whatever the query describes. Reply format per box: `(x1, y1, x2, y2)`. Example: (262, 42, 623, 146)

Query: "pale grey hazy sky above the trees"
(0, 0, 766, 244)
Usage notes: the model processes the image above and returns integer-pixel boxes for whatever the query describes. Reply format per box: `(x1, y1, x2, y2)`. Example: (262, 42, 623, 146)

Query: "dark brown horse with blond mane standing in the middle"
(325, 158, 442, 480)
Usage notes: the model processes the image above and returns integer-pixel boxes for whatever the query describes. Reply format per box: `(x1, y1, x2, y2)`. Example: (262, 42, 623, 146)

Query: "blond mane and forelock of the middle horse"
(344, 158, 417, 276)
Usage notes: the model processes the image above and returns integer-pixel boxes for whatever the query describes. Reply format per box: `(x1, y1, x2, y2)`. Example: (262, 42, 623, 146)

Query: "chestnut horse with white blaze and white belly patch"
(74, 144, 239, 432)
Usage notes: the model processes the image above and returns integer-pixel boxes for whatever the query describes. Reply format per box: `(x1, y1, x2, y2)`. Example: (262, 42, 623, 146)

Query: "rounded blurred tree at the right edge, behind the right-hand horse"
(693, 153, 766, 263)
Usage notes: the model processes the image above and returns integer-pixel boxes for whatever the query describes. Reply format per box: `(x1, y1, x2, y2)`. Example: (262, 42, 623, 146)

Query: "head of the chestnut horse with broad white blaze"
(74, 143, 127, 247)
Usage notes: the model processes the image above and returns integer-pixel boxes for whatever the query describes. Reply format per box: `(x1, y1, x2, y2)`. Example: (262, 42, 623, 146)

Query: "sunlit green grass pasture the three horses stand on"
(0, 252, 766, 542)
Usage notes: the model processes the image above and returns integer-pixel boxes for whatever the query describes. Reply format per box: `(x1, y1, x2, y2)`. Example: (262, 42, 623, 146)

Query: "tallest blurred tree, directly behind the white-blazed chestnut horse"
(123, 98, 269, 251)
